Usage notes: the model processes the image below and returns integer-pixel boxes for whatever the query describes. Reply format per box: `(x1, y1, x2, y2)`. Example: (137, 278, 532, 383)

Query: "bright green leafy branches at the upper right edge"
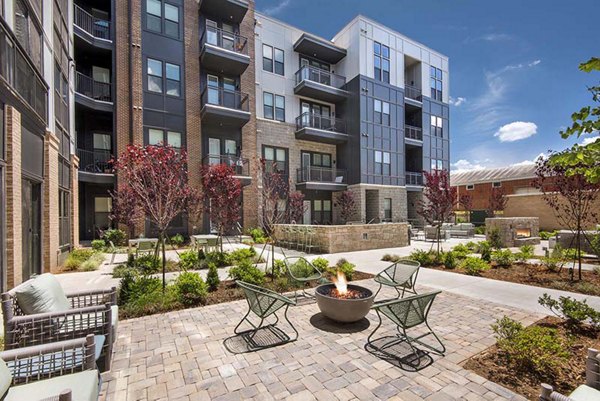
(550, 57, 600, 184)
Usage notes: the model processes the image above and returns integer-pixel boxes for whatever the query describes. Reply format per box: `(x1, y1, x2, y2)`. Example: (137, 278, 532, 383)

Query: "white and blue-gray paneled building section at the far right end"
(255, 13, 449, 224)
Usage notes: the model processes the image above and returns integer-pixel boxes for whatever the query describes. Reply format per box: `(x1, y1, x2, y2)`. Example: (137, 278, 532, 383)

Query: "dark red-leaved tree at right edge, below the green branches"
(532, 150, 600, 280)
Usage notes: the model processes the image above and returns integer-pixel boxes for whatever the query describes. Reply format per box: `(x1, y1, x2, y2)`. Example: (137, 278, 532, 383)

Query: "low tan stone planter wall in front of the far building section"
(275, 223, 409, 253)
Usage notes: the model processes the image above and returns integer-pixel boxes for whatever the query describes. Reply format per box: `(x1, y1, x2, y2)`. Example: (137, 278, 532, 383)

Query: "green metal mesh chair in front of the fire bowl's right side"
(365, 291, 446, 365)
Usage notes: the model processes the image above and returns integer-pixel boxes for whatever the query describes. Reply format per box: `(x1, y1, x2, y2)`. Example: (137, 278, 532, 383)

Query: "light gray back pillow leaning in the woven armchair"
(13, 273, 71, 315)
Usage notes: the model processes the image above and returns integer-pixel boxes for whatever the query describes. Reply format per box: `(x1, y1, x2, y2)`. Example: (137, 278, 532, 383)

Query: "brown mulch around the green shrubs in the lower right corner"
(463, 317, 600, 401)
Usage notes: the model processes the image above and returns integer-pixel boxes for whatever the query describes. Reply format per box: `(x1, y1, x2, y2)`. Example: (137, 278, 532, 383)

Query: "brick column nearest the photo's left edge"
(6, 106, 23, 289)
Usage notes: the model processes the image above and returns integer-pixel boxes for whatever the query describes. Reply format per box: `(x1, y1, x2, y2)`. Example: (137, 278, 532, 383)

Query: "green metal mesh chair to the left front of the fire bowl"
(233, 281, 298, 349)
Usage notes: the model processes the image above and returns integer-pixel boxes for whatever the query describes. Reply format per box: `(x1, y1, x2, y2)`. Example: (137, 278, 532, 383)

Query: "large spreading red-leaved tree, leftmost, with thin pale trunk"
(113, 145, 202, 291)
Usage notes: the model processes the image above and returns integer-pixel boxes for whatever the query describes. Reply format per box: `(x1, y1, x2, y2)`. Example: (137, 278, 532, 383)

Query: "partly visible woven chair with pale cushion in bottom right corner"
(540, 348, 600, 401)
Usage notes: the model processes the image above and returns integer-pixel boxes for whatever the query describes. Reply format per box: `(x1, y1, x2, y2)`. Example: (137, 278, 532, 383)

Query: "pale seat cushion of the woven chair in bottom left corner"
(4, 370, 98, 401)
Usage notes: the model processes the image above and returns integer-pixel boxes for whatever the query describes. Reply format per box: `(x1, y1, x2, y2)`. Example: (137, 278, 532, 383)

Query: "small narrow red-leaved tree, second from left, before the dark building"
(202, 164, 242, 252)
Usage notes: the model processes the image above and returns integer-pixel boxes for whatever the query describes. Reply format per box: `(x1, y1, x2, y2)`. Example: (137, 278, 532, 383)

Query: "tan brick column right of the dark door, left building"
(42, 131, 60, 273)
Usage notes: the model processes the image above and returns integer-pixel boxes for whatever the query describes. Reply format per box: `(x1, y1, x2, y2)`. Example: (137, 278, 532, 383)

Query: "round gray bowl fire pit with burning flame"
(315, 272, 375, 323)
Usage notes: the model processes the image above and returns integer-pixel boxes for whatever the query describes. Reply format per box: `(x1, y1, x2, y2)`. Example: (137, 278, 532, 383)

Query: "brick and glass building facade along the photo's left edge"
(0, 0, 79, 290)
